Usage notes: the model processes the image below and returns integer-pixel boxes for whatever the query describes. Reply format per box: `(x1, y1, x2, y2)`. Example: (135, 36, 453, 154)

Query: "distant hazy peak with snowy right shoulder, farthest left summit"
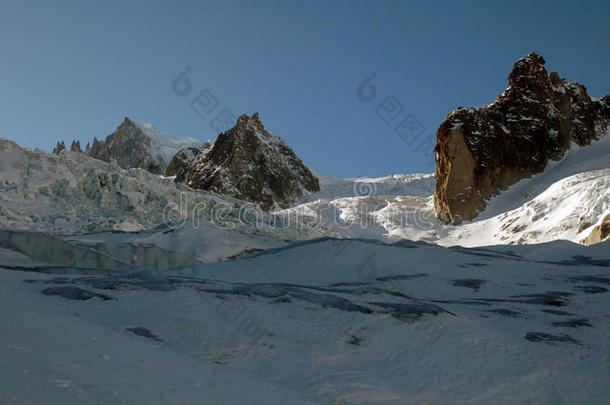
(53, 117, 202, 174)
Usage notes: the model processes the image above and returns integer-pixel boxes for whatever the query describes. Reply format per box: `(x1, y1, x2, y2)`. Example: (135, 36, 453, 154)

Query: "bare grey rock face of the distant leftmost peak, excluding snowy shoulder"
(89, 117, 167, 174)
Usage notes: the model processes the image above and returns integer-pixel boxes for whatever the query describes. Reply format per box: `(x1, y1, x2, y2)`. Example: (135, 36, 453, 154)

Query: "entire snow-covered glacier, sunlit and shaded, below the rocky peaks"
(0, 131, 610, 404)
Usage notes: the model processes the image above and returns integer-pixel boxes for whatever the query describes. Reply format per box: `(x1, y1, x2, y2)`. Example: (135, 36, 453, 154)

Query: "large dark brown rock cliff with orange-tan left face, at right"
(434, 53, 610, 224)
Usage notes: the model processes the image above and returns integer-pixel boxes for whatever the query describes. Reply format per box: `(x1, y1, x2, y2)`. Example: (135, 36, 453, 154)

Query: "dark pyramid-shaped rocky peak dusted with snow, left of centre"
(183, 113, 320, 210)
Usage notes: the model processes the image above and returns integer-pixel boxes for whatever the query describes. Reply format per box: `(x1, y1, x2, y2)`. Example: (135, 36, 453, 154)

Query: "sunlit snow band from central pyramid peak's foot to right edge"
(280, 136, 610, 246)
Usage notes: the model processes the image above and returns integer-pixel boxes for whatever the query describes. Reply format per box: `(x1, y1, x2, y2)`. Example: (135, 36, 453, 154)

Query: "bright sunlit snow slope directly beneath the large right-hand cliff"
(420, 136, 610, 246)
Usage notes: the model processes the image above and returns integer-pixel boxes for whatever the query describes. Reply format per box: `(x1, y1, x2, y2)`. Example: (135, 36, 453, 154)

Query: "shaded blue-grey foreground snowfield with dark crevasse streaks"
(0, 239, 610, 404)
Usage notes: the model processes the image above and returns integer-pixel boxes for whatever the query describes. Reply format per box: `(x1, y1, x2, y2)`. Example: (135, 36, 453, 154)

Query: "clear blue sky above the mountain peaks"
(0, 0, 610, 177)
